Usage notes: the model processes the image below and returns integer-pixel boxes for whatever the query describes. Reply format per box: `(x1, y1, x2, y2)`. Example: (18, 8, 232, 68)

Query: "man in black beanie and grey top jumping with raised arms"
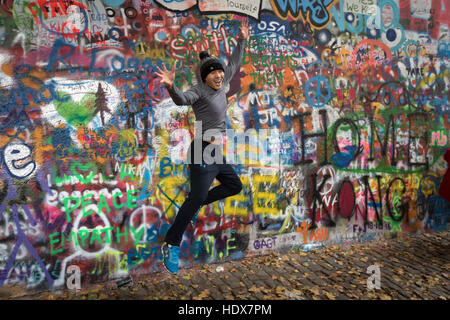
(156, 20, 249, 273)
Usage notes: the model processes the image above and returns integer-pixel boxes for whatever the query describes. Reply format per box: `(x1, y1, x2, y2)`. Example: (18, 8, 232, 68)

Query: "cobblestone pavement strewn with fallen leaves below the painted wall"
(2, 231, 450, 300)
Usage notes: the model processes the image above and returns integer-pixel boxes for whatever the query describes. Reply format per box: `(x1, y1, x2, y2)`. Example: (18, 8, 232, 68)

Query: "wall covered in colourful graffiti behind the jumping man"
(0, 0, 450, 291)
